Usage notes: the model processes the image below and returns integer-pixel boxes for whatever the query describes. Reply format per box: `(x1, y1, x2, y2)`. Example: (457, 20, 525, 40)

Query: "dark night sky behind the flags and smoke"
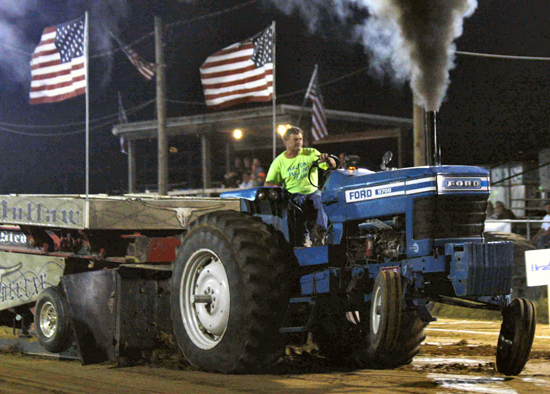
(0, 0, 550, 193)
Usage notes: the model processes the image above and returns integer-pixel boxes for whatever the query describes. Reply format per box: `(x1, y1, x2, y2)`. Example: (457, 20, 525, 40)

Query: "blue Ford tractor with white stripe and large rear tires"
(171, 151, 536, 375)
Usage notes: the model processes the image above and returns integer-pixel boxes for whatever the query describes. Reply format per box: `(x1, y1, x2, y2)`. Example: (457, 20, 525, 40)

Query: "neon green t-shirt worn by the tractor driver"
(265, 148, 328, 194)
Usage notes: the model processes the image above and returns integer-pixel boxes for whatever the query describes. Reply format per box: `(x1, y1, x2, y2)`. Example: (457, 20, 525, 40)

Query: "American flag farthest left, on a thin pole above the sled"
(30, 18, 86, 104)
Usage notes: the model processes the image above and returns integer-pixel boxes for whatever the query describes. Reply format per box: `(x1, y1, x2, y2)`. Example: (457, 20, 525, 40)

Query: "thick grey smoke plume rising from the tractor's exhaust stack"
(271, 0, 477, 111)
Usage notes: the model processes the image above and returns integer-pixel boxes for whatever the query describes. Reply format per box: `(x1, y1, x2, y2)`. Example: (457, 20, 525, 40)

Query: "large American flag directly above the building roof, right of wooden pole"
(200, 27, 274, 109)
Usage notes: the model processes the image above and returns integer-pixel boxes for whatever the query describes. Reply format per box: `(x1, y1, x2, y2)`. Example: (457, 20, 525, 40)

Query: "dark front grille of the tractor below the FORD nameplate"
(413, 195, 487, 239)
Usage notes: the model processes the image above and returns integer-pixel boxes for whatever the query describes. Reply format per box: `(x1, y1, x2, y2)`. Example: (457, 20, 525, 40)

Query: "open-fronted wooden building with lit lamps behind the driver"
(112, 104, 413, 193)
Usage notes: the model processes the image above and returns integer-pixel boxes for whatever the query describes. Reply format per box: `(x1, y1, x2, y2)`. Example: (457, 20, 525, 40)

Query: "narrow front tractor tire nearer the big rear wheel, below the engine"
(369, 271, 403, 354)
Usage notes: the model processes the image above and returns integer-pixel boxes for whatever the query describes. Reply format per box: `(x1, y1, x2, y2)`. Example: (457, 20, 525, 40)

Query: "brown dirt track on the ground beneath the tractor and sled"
(0, 319, 550, 394)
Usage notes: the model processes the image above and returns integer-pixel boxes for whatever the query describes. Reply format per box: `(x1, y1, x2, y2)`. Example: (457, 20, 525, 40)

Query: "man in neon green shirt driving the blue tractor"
(265, 127, 336, 246)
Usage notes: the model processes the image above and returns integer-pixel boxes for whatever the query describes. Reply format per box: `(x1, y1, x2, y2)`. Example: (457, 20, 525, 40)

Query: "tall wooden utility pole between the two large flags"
(155, 16, 168, 196)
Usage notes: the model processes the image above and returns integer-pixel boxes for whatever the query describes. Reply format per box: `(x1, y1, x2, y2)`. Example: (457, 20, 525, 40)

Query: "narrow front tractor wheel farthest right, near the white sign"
(497, 298, 537, 376)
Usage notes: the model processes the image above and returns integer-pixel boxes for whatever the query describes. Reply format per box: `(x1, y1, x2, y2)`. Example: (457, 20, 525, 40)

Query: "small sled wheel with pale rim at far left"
(34, 287, 72, 353)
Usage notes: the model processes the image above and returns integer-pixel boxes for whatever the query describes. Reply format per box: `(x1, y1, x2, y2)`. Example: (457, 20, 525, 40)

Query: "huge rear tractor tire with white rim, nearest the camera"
(171, 211, 293, 373)
